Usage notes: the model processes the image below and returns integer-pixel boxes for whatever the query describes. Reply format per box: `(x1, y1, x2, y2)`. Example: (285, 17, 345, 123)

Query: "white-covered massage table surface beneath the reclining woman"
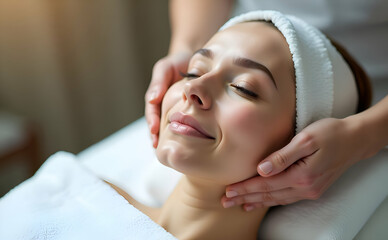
(77, 117, 388, 240)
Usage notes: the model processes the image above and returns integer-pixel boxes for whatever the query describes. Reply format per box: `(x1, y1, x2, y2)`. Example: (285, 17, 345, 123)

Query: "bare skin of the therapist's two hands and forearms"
(145, 0, 388, 208)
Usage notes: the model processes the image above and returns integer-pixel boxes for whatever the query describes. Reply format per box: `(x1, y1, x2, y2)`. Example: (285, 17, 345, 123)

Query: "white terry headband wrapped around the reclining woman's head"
(220, 11, 358, 133)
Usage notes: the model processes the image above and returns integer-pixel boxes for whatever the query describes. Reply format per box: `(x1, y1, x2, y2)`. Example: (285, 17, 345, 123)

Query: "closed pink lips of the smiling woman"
(169, 112, 215, 139)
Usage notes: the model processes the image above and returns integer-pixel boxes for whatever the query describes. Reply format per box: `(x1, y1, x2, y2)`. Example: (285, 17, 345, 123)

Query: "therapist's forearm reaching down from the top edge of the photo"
(169, 0, 233, 54)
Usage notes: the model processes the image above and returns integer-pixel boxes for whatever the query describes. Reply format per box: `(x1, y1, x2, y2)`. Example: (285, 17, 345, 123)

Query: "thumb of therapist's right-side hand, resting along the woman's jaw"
(257, 132, 318, 177)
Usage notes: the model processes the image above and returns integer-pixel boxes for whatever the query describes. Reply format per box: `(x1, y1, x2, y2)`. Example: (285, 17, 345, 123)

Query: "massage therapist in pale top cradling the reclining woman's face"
(145, 0, 388, 210)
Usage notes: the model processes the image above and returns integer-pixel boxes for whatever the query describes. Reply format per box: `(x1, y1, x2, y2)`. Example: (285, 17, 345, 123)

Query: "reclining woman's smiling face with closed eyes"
(156, 22, 295, 185)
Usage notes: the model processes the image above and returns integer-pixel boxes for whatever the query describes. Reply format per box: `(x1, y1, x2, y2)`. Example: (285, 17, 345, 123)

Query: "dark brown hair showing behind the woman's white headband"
(328, 37, 372, 113)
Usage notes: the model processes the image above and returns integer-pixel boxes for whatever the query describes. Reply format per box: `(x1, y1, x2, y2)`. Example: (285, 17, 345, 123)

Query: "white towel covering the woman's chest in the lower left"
(0, 152, 176, 240)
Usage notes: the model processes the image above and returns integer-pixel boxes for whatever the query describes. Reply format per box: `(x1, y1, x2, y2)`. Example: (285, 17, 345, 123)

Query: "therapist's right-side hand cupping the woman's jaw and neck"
(221, 119, 368, 211)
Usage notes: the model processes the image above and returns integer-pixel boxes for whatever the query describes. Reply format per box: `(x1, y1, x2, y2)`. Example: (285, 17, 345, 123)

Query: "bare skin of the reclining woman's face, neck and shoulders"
(111, 22, 295, 239)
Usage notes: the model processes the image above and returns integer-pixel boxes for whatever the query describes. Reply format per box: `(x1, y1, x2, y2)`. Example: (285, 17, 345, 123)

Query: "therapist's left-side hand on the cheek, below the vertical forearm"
(145, 52, 192, 148)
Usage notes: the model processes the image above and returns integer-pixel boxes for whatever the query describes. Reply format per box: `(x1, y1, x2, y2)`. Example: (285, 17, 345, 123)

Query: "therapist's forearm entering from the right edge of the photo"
(345, 96, 388, 159)
